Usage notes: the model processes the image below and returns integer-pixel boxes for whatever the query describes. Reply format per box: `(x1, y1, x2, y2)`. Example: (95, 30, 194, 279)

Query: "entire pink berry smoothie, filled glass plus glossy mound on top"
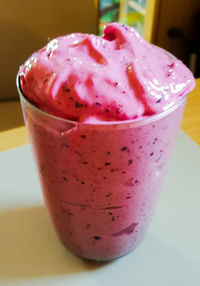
(18, 23, 195, 260)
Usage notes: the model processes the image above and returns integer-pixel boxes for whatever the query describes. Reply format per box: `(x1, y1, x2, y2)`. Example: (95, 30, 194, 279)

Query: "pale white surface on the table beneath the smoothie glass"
(0, 132, 200, 286)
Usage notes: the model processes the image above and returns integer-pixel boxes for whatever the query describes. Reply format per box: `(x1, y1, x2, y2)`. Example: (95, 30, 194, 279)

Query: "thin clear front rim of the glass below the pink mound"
(16, 72, 187, 129)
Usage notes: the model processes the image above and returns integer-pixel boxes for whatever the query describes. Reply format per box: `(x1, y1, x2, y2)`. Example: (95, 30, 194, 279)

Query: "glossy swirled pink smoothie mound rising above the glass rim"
(20, 23, 195, 122)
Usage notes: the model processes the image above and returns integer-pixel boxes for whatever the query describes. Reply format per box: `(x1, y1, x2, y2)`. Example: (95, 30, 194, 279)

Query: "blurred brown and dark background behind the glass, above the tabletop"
(0, 0, 200, 131)
